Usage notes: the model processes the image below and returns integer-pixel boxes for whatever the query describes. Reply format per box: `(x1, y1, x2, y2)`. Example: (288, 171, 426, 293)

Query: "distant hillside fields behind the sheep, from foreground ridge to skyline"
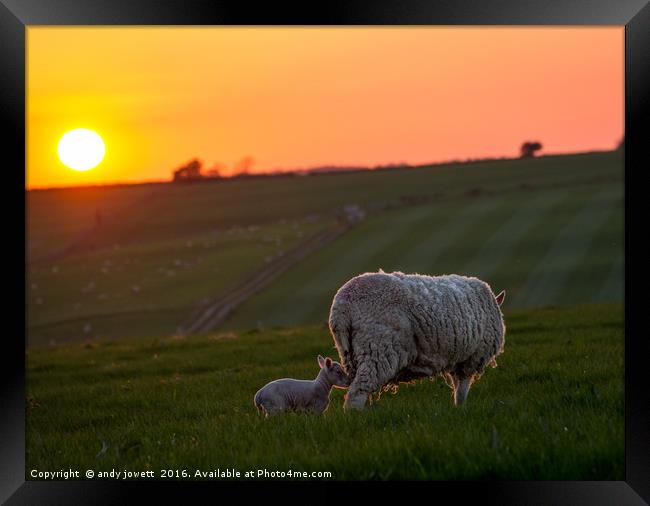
(27, 152, 623, 344)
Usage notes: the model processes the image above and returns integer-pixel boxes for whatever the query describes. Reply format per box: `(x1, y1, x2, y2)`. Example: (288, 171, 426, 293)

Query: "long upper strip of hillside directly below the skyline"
(27, 151, 623, 258)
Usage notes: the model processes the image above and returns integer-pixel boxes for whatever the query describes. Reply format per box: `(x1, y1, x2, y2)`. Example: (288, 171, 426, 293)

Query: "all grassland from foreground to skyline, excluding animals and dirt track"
(26, 152, 624, 480)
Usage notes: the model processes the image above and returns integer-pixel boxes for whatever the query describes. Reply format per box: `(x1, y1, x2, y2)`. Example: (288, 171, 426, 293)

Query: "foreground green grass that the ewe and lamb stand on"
(26, 304, 624, 480)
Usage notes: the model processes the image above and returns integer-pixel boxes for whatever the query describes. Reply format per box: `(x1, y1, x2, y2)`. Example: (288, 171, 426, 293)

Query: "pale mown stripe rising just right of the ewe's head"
(513, 188, 614, 307)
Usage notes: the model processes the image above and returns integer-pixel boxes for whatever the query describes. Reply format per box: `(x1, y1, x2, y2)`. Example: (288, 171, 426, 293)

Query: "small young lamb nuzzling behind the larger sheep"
(253, 355, 350, 417)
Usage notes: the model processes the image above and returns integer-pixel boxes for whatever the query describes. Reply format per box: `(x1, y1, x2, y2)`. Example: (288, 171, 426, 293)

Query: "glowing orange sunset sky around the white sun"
(26, 26, 624, 188)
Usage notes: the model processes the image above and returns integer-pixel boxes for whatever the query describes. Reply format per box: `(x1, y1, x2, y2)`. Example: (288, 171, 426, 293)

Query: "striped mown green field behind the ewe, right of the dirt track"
(224, 183, 623, 329)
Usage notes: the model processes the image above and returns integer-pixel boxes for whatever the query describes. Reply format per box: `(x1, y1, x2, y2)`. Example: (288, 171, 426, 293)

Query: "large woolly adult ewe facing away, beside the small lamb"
(329, 270, 505, 410)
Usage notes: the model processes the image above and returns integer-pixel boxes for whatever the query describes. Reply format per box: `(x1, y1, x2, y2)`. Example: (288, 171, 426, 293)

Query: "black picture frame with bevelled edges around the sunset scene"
(0, 0, 650, 505)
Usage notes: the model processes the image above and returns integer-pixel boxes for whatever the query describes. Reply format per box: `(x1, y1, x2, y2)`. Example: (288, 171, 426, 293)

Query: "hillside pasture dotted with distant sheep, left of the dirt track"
(27, 220, 324, 344)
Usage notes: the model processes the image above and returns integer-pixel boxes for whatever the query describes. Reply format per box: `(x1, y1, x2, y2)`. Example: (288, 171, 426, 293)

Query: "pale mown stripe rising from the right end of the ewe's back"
(463, 191, 567, 279)
